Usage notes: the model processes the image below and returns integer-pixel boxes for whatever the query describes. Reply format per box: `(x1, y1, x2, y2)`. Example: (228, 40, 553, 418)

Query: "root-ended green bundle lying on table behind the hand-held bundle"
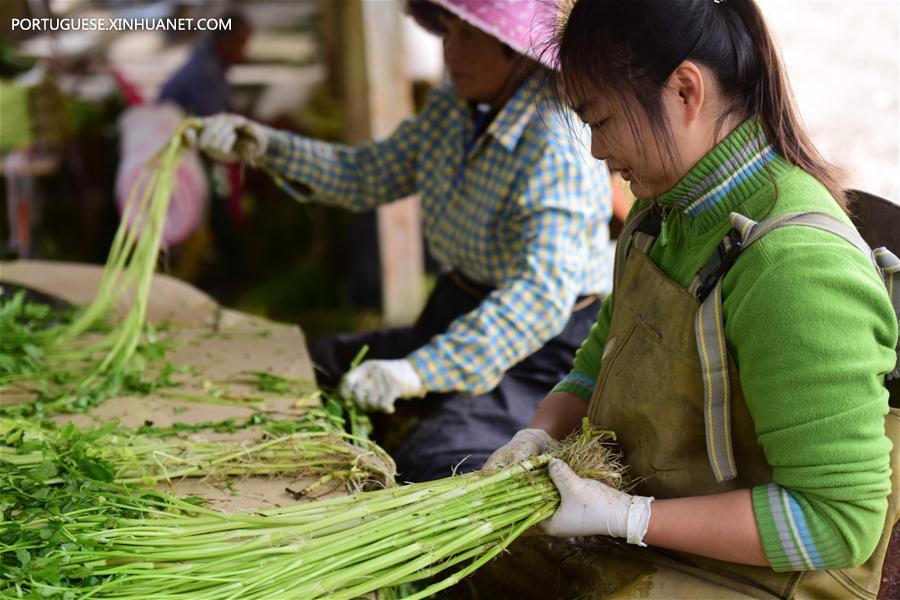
(0, 418, 396, 495)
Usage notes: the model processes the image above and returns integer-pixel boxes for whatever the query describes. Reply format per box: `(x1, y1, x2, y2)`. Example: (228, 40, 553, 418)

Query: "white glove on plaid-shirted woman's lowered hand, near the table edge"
(340, 360, 425, 413)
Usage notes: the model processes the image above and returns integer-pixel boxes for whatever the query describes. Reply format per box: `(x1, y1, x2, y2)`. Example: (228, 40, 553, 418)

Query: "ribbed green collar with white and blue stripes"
(657, 117, 790, 233)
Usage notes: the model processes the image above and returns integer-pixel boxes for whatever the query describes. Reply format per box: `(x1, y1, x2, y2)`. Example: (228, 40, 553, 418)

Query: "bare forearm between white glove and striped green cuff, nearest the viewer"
(644, 489, 769, 566)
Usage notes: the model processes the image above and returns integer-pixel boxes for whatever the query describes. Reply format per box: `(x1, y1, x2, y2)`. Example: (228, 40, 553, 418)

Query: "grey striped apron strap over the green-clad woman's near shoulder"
(690, 212, 900, 482)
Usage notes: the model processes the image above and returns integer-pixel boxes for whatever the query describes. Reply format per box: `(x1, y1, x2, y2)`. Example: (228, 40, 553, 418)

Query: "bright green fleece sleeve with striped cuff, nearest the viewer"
(723, 227, 897, 571)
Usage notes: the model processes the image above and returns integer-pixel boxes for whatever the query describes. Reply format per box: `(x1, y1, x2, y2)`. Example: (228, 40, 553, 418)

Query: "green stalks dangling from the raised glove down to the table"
(0, 120, 193, 412)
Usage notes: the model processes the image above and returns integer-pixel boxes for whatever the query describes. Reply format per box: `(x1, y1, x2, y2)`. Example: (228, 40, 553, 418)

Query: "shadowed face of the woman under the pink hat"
(441, 15, 515, 102)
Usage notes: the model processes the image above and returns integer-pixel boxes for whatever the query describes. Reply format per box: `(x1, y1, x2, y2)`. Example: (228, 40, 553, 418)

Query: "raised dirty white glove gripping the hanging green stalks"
(184, 113, 272, 165)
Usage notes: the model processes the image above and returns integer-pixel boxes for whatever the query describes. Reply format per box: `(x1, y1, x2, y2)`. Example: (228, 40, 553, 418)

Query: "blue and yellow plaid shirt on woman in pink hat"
(266, 78, 611, 394)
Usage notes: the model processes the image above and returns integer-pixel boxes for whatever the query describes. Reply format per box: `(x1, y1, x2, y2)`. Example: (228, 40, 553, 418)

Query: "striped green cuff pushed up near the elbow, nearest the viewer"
(753, 483, 832, 571)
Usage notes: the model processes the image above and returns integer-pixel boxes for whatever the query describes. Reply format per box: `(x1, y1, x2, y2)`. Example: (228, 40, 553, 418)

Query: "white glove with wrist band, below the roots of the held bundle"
(538, 459, 654, 546)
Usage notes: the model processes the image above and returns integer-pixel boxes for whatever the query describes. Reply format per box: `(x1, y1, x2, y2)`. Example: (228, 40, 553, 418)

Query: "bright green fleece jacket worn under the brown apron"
(554, 119, 897, 571)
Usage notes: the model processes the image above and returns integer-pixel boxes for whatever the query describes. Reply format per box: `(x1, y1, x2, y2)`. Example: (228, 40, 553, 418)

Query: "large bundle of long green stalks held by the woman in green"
(0, 422, 622, 599)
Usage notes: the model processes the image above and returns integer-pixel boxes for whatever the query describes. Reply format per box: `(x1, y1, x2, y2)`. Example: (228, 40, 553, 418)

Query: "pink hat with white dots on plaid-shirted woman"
(406, 0, 557, 69)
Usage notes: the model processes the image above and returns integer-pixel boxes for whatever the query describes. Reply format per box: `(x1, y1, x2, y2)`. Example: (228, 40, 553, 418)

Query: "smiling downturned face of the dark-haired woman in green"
(575, 88, 680, 199)
